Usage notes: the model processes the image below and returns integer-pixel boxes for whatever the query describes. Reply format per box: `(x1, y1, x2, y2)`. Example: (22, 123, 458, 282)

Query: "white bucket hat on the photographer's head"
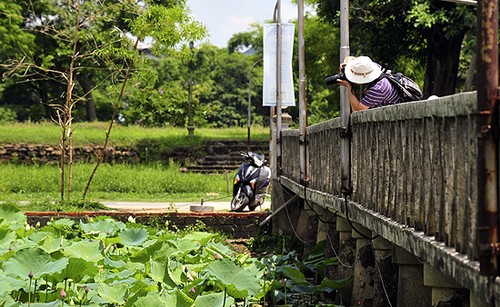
(345, 56, 382, 84)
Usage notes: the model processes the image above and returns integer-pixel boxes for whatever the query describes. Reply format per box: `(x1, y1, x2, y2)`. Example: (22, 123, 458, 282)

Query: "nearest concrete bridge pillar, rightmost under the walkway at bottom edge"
(424, 264, 469, 307)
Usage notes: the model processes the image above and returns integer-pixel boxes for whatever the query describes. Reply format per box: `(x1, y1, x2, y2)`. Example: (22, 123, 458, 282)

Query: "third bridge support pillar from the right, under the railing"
(372, 233, 398, 307)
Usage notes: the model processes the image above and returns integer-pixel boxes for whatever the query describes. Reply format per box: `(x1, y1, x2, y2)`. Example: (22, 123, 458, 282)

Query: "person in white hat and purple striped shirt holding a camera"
(336, 56, 401, 111)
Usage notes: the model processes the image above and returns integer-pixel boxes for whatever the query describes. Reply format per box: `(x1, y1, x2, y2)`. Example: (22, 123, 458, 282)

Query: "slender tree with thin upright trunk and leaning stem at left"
(2, 0, 206, 200)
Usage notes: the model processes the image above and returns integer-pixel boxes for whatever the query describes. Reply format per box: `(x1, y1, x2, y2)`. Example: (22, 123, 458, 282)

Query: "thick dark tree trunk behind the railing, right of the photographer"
(424, 26, 464, 97)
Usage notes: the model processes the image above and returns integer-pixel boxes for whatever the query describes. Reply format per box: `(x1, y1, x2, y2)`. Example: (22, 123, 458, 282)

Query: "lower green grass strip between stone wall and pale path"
(0, 164, 233, 202)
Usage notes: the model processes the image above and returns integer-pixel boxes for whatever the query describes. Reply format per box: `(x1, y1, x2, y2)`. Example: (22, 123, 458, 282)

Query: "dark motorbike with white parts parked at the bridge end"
(231, 152, 271, 212)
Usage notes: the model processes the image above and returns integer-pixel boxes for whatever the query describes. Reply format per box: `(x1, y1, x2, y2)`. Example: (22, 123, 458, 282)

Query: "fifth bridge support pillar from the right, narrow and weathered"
(331, 217, 356, 306)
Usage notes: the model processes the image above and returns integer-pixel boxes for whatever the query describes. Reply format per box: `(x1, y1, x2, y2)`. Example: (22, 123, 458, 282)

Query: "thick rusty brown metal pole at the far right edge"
(476, 0, 500, 276)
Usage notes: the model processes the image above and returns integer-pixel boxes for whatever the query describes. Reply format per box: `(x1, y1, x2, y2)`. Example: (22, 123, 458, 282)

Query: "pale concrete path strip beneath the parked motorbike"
(101, 200, 271, 212)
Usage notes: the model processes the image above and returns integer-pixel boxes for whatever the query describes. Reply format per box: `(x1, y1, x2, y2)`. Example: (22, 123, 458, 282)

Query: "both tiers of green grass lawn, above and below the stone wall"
(0, 123, 269, 208)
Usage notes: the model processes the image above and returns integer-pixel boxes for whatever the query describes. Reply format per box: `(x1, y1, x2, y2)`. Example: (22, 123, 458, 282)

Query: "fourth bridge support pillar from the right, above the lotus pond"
(352, 224, 377, 306)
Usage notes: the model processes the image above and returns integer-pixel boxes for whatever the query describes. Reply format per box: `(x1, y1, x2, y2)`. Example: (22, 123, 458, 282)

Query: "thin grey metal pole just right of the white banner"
(298, 0, 309, 186)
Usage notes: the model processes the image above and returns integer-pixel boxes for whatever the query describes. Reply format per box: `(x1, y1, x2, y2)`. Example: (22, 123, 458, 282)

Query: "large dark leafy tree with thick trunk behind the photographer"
(315, 0, 475, 97)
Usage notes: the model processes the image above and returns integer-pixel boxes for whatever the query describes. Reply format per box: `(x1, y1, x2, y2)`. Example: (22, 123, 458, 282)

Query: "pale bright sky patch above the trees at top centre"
(186, 0, 297, 47)
